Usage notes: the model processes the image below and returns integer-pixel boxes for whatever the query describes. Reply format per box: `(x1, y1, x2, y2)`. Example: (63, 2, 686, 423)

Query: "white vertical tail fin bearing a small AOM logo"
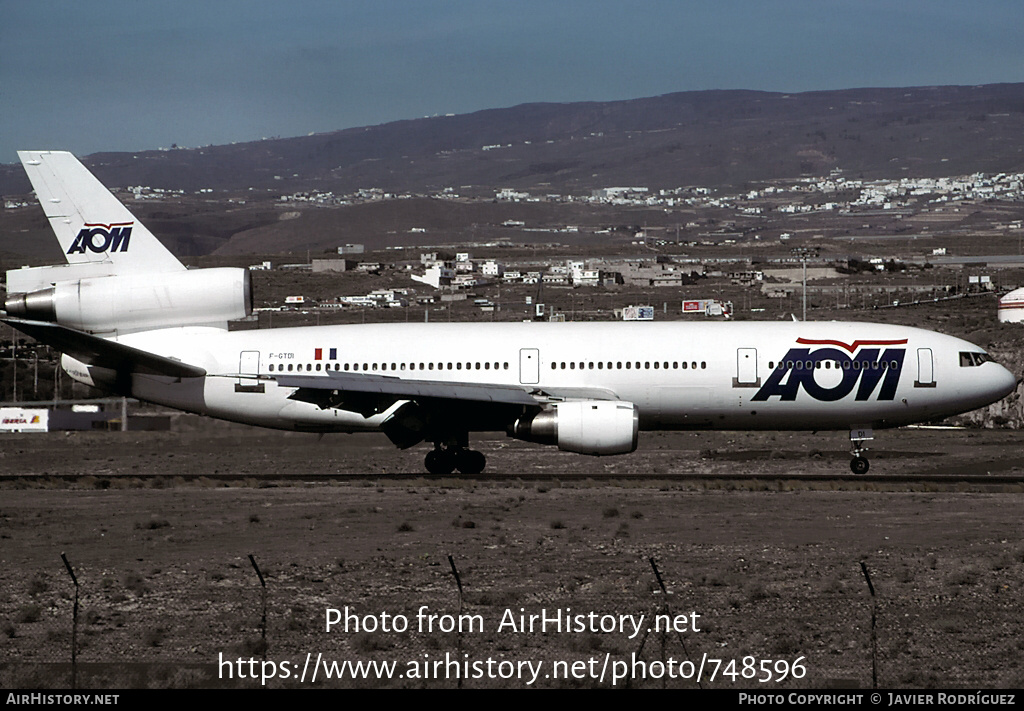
(17, 151, 185, 274)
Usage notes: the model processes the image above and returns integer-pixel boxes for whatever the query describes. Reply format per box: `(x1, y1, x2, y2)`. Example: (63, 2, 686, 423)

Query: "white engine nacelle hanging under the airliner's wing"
(509, 400, 640, 455)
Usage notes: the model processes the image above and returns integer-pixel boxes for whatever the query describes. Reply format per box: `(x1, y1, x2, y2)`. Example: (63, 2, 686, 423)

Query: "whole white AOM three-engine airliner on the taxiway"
(3, 152, 1016, 474)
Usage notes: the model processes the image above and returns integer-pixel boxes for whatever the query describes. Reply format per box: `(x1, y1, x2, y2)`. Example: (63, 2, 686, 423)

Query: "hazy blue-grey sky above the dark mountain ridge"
(0, 0, 1024, 163)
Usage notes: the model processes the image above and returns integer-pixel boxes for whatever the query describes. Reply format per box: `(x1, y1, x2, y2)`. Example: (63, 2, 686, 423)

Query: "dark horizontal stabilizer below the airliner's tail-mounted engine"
(2, 318, 206, 378)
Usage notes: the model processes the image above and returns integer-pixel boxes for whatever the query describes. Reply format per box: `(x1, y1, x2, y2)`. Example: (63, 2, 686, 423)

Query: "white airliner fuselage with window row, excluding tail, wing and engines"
(72, 322, 1016, 431)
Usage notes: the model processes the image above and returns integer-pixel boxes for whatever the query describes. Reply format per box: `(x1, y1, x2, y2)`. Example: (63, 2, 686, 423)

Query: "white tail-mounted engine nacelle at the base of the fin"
(4, 267, 252, 333)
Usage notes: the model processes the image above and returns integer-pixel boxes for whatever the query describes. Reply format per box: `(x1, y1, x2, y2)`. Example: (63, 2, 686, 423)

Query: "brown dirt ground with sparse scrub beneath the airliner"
(0, 418, 1024, 689)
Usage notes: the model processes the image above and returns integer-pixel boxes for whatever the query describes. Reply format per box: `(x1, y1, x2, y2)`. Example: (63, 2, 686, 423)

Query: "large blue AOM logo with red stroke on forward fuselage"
(751, 338, 907, 403)
